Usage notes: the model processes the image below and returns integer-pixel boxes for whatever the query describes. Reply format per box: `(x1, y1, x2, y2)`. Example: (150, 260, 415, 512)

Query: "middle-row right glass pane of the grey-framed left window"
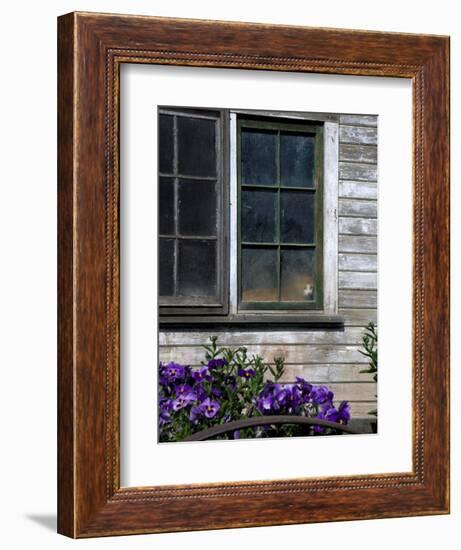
(178, 180, 216, 237)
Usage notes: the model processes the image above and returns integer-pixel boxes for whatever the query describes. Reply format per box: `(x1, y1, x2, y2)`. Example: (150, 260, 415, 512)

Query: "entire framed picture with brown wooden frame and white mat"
(58, 13, 449, 537)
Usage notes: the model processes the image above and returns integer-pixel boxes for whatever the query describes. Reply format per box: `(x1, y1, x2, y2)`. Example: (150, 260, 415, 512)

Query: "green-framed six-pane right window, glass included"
(237, 118, 323, 310)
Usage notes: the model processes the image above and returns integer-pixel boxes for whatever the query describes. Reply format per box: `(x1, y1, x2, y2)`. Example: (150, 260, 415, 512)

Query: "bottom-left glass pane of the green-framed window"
(241, 247, 278, 302)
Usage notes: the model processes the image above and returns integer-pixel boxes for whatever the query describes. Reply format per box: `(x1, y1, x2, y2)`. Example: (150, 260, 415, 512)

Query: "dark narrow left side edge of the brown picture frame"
(57, 12, 76, 536)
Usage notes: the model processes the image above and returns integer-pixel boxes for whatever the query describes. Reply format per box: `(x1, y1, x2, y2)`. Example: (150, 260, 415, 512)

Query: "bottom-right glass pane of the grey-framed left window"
(178, 239, 216, 298)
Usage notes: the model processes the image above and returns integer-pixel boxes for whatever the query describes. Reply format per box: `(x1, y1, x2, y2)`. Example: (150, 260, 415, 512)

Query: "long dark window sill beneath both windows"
(159, 313, 344, 330)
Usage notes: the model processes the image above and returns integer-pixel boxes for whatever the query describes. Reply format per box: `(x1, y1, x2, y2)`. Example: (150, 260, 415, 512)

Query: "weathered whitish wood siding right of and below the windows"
(160, 115, 378, 417)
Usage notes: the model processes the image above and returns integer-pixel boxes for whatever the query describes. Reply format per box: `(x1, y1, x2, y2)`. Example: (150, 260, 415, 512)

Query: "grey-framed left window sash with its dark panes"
(158, 108, 227, 313)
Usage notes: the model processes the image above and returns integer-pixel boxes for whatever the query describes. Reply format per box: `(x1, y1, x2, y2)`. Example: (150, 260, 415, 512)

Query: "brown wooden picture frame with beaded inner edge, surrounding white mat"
(58, 13, 449, 537)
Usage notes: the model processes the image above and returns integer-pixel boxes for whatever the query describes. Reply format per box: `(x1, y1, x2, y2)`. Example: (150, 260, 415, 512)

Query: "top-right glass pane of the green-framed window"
(280, 132, 315, 187)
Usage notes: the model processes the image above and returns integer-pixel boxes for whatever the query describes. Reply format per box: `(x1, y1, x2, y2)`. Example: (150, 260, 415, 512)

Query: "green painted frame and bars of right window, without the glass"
(237, 116, 324, 312)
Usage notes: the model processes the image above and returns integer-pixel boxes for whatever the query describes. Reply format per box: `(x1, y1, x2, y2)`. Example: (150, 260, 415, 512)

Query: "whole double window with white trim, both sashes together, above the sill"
(158, 107, 338, 325)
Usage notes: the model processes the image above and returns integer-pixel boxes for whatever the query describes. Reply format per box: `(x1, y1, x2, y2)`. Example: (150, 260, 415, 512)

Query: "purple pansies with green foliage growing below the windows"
(159, 336, 350, 441)
